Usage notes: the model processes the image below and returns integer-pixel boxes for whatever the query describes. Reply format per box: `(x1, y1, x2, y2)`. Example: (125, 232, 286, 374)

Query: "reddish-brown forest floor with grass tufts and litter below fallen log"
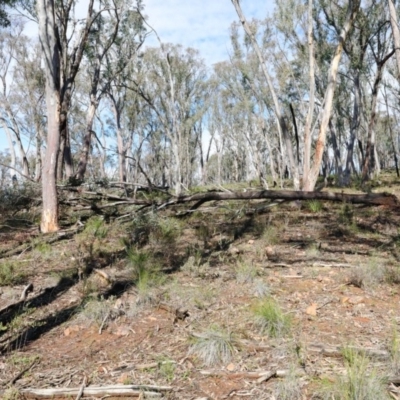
(0, 178, 400, 400)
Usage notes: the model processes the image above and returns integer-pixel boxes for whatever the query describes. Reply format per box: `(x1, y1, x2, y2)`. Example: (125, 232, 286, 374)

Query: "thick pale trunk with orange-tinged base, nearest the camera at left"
(37, 0, 61, 233)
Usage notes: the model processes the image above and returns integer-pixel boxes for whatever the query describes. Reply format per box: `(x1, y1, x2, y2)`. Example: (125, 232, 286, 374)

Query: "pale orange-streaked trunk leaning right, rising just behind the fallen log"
(303, 0, 360, 191)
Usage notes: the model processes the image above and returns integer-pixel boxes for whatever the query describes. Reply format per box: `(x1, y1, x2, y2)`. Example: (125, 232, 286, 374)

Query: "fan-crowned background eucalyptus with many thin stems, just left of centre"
(131, 43, 208, 196)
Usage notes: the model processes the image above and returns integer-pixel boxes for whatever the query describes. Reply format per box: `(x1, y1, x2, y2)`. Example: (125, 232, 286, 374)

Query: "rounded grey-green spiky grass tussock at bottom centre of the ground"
(189, 325, 237, 366)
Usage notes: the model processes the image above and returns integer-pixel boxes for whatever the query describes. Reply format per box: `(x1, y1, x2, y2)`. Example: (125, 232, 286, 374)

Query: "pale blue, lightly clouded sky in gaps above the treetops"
(0, 0, 275, 155)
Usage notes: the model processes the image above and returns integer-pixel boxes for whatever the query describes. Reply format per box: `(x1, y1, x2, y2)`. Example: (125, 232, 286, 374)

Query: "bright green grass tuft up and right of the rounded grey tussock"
(253, 297, 292, 337)
